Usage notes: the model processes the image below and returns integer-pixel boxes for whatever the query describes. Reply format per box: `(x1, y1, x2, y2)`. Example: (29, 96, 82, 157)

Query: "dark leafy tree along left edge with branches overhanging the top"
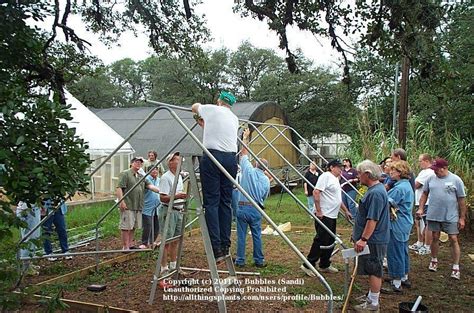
(0, 0, 208, 310)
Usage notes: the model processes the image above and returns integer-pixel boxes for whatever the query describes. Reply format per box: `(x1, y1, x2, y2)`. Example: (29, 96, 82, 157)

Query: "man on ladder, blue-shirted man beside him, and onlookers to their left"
(116, 91, 270, 288)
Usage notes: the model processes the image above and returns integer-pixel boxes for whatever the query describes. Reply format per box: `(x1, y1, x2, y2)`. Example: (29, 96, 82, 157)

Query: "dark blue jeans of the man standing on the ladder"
(200, 149, 237, 254)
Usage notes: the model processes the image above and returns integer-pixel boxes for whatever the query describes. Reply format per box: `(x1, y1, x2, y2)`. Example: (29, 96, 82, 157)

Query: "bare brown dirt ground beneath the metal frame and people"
(26, 225, 474, 312)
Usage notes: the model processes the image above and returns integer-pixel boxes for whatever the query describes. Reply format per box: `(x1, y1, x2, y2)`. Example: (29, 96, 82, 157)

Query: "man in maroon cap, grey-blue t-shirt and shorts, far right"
(416, 159, 467, 280)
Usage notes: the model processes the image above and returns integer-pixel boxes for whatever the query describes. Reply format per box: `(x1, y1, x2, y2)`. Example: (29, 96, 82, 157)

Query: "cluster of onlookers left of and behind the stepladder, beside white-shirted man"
(116, 151, 187, 288)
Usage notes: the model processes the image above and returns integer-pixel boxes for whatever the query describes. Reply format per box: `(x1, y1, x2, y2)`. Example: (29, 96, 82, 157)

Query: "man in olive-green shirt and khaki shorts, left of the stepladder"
(115, 157, 159, 250)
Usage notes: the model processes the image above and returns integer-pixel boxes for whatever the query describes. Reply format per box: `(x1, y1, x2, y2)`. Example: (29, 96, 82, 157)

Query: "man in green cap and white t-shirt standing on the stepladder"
(192, 91, 239, 260)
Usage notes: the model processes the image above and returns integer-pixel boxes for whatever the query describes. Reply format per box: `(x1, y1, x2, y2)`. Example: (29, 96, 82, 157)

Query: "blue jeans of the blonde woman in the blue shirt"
(387, 231, 410, 279)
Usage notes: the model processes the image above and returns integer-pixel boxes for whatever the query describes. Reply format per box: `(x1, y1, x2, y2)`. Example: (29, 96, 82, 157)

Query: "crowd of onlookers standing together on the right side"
(301, 148, 466, 311)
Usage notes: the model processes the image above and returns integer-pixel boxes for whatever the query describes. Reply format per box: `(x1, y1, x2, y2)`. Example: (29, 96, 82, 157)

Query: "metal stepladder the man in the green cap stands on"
(148, 154, 243, 312)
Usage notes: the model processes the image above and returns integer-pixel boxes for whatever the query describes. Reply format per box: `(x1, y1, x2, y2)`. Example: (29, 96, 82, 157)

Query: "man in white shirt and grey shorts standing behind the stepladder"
(158, 152, 186, 289)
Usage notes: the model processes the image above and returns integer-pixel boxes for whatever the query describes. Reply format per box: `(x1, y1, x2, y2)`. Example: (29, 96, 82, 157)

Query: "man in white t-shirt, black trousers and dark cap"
(301, 159, 352, 277)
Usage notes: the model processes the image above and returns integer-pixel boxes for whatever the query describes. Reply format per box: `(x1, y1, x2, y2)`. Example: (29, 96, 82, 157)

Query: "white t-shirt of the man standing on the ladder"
(198, 104, 239, 152)
